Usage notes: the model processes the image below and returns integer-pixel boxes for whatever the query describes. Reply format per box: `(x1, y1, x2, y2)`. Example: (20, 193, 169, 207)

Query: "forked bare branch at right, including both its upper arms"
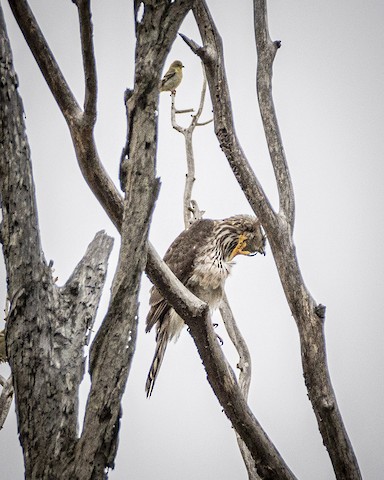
(182, 0, 360, 479)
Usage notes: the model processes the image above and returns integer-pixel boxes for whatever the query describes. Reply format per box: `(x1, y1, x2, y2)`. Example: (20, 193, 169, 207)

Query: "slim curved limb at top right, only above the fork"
(253, 0, 295, 230)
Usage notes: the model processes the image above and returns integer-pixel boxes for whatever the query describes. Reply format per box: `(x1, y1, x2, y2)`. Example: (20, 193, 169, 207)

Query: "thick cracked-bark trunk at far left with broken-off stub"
(0, 5, 113, 479)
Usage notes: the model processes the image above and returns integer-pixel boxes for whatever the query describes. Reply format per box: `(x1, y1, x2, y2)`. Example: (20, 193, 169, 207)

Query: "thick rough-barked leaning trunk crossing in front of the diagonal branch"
(66, 1, 195, 479)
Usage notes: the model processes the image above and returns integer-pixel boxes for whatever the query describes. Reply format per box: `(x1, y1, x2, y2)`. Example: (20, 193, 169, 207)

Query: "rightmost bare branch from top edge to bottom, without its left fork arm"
(254, 0, 361, 480)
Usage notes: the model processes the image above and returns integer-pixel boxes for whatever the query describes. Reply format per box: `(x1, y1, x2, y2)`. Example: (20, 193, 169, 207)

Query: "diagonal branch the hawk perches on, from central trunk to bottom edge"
(147, 256, 295, 480)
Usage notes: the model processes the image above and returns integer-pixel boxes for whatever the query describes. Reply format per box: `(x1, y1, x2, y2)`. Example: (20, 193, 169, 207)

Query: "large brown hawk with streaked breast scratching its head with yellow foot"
(145, 215, 265, 397)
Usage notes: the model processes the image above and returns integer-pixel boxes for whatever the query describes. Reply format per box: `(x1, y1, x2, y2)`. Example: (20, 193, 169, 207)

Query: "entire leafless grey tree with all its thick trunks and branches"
(0, 0, 361, 480)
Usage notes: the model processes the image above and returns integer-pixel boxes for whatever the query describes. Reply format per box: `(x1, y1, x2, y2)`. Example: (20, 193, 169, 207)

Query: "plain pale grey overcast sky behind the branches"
(0, 0, 384, 480)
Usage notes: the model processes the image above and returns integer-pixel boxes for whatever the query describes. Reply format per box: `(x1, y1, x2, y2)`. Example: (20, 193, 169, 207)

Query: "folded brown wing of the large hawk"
(146, 219, 214, 332)
